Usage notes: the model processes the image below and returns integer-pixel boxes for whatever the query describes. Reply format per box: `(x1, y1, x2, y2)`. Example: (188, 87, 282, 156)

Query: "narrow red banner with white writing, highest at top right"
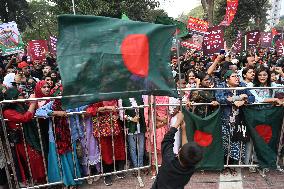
(220, 0, 239, 26)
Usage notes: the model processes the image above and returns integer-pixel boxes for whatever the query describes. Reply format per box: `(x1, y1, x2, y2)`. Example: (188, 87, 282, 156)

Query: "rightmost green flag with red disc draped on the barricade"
(243, 107, 284, 168)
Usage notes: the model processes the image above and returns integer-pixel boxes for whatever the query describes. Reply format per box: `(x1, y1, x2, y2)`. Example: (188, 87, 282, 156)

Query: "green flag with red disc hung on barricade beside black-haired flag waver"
(183, 108, 224, 170)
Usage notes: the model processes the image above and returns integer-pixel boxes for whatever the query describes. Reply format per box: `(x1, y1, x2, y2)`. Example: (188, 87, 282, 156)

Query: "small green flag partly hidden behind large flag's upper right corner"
(155, 16, 188, 37)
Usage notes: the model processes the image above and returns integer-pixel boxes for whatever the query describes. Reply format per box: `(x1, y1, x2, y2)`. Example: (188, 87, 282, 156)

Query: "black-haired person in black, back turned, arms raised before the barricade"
(152, 112, 203, 189)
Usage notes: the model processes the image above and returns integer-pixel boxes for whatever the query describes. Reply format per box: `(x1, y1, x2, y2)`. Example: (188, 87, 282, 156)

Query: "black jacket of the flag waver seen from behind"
(152, 127, 195, 189)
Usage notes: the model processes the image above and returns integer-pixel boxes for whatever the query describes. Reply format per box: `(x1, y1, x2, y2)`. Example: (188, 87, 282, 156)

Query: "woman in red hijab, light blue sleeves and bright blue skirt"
(36, 84, 81, 187)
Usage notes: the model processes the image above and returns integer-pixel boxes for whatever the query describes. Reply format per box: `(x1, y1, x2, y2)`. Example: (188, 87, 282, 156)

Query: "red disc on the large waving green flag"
(120, 34, 149, 77)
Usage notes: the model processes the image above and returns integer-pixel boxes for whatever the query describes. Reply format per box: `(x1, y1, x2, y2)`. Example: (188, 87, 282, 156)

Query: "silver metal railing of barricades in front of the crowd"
(0, 87, 284, 188)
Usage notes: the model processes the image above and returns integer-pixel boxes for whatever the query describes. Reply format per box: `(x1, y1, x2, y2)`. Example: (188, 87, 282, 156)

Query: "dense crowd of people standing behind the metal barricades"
(0, 44, 284, 187)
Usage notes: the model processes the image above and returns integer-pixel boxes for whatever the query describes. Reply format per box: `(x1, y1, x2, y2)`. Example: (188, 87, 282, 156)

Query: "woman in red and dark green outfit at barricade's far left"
(3, 88, 45, 184)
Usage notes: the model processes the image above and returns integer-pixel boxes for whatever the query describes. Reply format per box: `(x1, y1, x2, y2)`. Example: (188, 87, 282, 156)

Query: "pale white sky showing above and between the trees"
(159, 0, 284, 18)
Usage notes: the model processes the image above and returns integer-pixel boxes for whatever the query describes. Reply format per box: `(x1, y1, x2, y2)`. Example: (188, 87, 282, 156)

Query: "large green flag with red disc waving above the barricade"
(57, 15, 177, 108)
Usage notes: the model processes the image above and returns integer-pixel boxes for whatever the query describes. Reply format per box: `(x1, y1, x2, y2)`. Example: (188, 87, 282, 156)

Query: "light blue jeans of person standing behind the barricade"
(127, 133, 145, 167)
